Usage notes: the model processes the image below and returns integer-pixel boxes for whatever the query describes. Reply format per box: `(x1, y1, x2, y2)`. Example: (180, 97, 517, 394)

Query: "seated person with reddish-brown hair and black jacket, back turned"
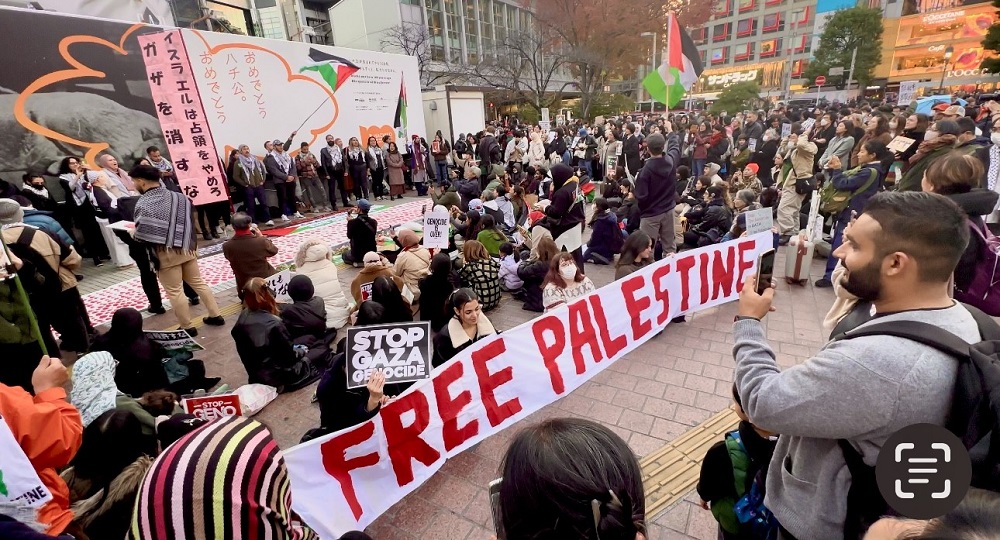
(231, 278, 326, 393)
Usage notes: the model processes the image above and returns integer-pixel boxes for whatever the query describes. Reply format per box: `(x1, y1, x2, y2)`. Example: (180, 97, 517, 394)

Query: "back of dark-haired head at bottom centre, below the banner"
(497, 418, 647, 540)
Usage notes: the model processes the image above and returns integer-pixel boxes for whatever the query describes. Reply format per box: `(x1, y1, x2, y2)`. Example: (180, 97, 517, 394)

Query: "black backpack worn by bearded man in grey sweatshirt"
(834, 304, 1000, 540)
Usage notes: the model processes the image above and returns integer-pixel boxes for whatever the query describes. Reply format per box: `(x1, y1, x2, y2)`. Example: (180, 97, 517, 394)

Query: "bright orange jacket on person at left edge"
(0, 384, 83, 536)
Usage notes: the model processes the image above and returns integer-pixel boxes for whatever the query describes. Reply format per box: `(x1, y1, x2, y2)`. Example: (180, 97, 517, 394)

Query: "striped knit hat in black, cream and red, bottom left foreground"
(127, 416, 319, 540)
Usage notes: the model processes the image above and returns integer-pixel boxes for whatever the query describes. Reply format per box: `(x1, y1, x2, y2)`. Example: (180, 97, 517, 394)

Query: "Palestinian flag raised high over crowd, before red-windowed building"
(642, 13, 703, 108)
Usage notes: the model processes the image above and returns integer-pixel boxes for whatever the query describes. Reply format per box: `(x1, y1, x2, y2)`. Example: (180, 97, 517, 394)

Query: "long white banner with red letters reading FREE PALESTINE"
(285, 231, 773, 539)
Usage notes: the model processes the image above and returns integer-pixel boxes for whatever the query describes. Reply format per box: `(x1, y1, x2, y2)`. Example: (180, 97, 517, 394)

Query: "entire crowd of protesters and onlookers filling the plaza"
(0, 89, 1000, 540)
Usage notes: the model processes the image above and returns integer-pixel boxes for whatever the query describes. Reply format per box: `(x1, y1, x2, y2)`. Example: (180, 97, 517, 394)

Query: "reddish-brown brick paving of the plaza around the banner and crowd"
(109, 195, 833, 540)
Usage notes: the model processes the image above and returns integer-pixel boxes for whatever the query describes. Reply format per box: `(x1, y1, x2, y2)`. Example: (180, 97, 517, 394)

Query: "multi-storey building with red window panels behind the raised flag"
(690, 0, 816, 101)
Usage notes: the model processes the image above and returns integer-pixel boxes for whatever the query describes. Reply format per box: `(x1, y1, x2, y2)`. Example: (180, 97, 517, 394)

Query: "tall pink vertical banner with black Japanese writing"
(137, 30, 228, 206)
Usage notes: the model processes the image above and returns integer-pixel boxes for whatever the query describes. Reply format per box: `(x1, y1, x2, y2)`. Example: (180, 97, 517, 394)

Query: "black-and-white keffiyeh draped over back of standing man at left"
(135, 187, 196, 251)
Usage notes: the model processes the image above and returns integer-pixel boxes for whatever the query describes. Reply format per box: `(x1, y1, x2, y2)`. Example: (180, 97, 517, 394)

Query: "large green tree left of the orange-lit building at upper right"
(803, 6, 882, 86)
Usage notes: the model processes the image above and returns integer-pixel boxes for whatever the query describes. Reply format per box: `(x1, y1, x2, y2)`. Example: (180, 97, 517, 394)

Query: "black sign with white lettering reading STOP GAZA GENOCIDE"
(345, 321, 431, 388)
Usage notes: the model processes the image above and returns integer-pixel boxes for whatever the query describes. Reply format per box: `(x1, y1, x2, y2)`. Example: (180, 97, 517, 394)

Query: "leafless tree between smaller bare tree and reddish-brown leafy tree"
(464, 28, 575, 111)
